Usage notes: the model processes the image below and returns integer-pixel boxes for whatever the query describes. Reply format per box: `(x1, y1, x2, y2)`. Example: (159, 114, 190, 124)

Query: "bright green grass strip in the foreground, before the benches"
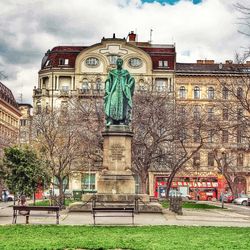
(0, 225, 250, 250)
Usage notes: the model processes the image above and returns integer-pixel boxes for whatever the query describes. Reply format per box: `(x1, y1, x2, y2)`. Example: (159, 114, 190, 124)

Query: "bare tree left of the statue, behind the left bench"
(33, 109, 82, 205)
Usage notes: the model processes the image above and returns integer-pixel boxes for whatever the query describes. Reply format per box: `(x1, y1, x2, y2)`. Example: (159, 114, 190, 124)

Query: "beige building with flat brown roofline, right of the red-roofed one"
(170, 60, 250, 197)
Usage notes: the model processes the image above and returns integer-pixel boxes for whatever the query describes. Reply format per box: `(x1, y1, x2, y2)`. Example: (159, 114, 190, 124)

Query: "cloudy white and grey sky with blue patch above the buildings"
(0, 0, 250, 103)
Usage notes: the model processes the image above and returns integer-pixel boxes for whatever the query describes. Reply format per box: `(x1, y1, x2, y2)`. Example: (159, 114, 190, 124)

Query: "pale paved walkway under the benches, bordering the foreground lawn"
(0, 201, 250, 227)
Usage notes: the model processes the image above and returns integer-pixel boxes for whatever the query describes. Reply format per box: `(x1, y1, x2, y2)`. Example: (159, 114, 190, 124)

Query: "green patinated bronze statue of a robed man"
(104, 58, 135, 127)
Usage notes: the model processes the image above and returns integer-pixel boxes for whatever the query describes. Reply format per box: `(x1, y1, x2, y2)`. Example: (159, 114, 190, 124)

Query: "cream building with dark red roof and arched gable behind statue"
(33, 32, 175, 193)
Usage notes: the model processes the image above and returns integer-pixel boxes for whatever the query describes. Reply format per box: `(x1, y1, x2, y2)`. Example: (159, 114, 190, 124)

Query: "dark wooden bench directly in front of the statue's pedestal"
(92, 207, 135, 225)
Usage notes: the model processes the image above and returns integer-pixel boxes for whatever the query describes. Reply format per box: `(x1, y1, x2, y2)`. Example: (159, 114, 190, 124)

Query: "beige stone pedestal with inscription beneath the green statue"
(97, 125, 135, 194)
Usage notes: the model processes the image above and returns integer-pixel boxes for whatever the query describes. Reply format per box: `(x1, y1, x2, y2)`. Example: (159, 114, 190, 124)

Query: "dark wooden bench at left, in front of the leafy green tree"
(12, 206, 60, 224)
